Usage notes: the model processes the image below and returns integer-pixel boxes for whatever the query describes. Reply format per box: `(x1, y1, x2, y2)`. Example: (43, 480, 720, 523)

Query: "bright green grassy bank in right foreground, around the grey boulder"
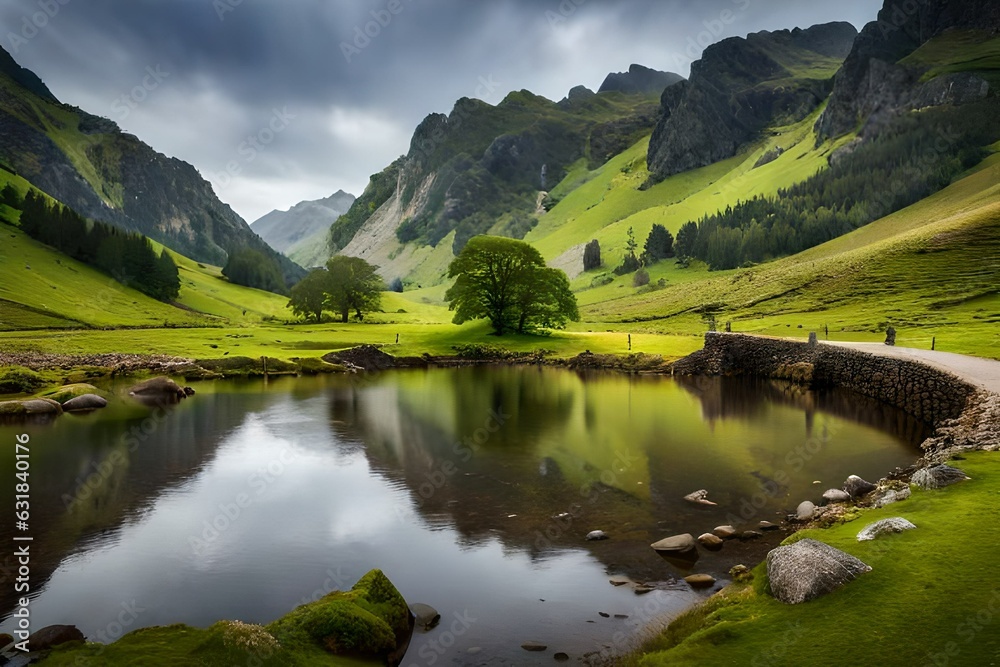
(625, 452, 1000, 667)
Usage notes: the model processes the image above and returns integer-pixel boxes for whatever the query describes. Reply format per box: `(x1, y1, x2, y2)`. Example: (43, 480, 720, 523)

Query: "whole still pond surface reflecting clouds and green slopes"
(0, 368, 924, 665)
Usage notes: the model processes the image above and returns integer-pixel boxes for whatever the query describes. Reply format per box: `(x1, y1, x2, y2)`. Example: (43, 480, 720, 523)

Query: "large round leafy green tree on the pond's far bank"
(445, 236, 579, 336)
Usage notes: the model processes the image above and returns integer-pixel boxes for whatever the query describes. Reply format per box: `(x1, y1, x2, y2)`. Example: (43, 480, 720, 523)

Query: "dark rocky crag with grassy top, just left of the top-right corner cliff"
(648, 23, 858, 181)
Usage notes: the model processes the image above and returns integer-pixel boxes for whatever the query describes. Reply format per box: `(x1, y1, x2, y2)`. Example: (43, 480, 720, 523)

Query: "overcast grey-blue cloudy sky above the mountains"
(0, 0, 882, 222)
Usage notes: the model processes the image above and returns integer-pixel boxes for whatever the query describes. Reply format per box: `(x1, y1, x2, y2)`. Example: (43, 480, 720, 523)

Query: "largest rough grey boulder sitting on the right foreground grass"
(767, 538, 871, 604)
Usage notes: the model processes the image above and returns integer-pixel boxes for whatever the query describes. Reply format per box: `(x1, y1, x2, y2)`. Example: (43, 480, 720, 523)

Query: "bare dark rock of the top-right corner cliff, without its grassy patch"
(816, 0, 1000, 140)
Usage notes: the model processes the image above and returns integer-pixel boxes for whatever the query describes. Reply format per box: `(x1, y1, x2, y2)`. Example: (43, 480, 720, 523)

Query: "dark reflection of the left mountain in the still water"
(0, 394, 274, 616)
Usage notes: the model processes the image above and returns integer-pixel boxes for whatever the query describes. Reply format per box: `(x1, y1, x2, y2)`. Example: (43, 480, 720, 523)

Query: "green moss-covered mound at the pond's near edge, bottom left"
(39, 570, 411, 667)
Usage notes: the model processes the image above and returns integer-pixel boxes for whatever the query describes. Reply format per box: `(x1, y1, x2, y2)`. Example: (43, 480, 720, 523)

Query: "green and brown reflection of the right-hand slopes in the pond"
(329, 368, 913, 577)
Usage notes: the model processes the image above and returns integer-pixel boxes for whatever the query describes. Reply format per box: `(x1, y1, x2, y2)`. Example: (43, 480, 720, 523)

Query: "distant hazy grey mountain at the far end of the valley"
(250, 190, 356, 257)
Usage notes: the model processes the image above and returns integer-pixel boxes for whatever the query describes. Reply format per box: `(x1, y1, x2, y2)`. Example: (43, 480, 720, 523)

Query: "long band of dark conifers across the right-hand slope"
(677, 103, 1000, 270)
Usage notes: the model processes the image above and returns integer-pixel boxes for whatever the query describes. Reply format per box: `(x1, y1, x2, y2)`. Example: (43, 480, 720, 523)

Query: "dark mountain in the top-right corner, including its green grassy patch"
(817, 0, 1000, 140)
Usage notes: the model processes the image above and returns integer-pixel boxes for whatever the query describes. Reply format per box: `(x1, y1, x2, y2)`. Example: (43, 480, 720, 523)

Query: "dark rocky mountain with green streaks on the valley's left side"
(0, 49, 304, 283)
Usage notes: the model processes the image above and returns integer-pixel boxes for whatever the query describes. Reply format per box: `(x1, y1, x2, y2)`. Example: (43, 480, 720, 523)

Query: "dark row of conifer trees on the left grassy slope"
(12, 190, 181, 301)
